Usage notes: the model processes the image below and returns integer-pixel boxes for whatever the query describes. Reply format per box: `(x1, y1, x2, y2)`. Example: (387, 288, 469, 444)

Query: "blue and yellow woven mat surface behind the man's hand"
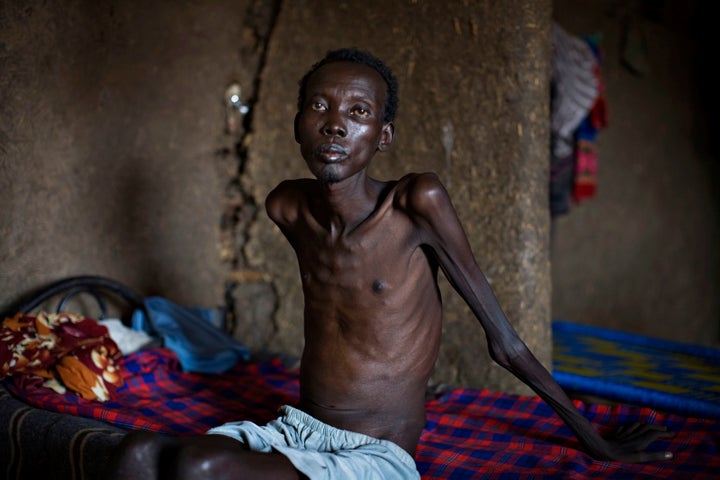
(553, 321, 720, 419)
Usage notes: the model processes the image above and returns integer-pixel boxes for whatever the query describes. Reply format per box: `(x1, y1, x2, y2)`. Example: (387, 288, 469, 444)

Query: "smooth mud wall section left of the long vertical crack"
(0, 0, 276, 310)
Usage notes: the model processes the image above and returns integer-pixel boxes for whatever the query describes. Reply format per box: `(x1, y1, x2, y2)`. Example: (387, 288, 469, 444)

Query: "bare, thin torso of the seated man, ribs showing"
(276, 173, 441, 452)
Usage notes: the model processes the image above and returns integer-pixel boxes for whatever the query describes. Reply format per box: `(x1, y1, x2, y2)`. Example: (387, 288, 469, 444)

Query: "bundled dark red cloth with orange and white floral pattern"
(0, 312, 123, 402)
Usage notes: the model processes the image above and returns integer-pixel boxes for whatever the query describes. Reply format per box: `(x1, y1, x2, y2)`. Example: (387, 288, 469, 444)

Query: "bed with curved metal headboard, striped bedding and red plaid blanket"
(0, 277, 720, 480)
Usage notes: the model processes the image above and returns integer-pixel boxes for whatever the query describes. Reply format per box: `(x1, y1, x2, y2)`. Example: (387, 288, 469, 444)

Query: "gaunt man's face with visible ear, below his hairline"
(295, 62, 393, 183)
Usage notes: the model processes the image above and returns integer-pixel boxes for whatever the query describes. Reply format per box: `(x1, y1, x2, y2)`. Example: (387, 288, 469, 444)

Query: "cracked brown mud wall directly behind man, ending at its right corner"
(0, 0, 550, 389)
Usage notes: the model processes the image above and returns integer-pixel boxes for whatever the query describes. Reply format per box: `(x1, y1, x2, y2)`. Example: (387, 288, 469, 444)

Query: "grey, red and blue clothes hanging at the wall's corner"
(550, 23, 607, 217)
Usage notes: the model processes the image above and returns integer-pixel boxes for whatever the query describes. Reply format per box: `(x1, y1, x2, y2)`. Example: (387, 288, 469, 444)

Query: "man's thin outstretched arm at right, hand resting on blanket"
(408, 174, 672, 462)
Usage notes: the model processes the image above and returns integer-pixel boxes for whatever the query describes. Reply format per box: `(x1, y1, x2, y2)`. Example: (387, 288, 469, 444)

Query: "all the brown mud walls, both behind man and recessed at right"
(7, 0, 720, 390)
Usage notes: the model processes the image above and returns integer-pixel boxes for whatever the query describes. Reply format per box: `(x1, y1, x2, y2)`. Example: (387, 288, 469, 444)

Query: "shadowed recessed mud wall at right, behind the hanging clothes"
(552, 0, 720, 346)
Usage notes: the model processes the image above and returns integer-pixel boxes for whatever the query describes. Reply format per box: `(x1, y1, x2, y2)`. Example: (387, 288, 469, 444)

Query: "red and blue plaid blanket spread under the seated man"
(6, 349, 720, 480)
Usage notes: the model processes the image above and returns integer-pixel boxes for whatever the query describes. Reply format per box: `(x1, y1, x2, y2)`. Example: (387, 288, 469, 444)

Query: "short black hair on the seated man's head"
(298, 48, 398, 123)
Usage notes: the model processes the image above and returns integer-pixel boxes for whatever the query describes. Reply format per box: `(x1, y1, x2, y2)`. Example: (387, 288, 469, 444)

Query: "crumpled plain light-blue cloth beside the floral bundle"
(132, 297, 250, 373)
